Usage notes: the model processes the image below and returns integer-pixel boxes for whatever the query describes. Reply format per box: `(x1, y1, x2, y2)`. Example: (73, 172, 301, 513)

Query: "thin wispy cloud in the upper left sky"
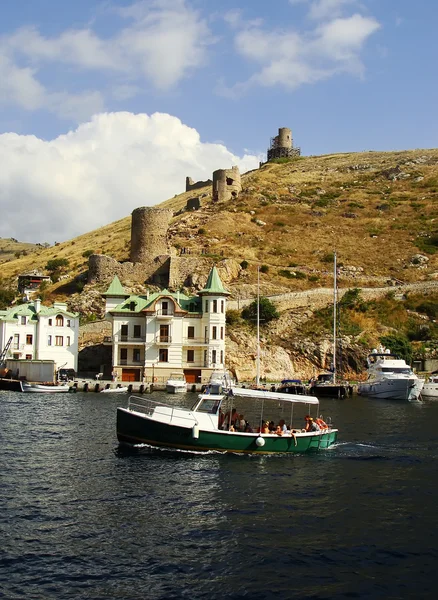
(0, 0, 210, 120)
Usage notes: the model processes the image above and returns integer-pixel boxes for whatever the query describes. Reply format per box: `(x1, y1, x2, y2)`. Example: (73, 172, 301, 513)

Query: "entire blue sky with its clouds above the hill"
(0, 0, 438, 243)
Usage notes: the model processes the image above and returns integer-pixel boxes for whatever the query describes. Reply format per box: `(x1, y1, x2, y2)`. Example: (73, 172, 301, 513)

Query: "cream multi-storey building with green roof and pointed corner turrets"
(104, 267, 229, 383)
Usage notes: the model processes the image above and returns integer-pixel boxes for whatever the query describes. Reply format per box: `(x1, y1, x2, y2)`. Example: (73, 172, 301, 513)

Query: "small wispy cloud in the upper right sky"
(225, 14, 380, 96)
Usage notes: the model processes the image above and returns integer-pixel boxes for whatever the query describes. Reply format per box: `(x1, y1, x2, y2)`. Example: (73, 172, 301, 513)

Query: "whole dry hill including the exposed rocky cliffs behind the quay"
(2, 149, 438, 377)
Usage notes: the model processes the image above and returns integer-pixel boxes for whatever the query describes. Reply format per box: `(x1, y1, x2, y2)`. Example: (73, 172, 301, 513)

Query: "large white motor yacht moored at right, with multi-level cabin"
(357, 348, 424, 400)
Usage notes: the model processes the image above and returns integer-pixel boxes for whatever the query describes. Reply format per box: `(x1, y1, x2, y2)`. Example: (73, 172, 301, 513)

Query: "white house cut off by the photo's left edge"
(0, 300, 79, 371)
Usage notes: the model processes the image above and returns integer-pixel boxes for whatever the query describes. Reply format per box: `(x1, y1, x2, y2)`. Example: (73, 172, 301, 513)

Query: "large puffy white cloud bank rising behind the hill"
(0, 112, 259, 242)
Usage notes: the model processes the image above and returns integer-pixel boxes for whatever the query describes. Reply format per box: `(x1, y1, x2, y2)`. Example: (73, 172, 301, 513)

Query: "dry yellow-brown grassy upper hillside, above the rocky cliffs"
(2, 150, 438, 298)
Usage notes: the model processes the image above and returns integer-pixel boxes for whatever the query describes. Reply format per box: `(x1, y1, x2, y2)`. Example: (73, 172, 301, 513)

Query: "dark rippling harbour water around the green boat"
(0, 392, 438, 600)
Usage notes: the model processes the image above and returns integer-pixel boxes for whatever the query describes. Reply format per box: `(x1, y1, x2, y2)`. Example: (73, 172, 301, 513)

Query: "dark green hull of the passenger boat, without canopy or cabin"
(117, 408, 338, 454)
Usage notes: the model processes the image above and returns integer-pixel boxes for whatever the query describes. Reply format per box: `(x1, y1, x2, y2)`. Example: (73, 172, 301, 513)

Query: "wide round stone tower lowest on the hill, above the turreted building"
(131, 206, 173, 263)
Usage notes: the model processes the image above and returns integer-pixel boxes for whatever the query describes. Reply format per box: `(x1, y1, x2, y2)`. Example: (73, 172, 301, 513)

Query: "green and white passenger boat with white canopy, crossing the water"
(117, 384, 338, 454)
